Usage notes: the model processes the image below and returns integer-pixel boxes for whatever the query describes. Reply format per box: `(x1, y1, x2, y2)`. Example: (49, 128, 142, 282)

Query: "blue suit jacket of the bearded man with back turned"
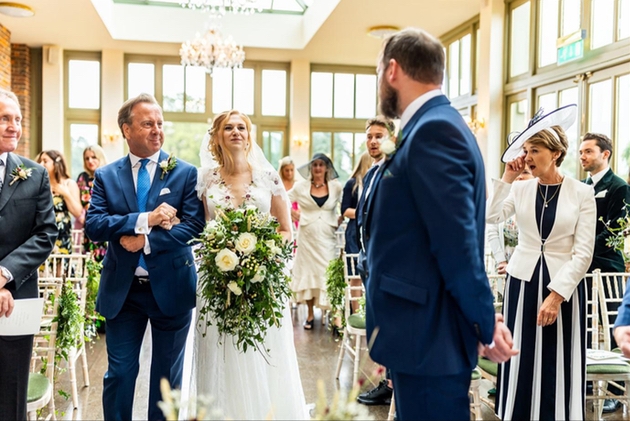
(363, 95, 494, 375)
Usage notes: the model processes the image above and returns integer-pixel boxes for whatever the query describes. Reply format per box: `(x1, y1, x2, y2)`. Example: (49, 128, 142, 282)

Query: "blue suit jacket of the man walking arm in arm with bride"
(85, 151, 205, 318)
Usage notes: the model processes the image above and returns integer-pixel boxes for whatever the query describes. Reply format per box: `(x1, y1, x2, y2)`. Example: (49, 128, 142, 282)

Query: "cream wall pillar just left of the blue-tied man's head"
(101, 50, 125, 162)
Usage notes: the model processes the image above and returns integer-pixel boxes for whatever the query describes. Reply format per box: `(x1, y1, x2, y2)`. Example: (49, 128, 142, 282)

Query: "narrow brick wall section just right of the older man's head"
(11, 44, 31, 156)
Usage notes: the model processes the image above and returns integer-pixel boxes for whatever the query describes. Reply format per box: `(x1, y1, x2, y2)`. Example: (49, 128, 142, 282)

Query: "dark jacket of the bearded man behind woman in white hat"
(588, 169, 630, 272)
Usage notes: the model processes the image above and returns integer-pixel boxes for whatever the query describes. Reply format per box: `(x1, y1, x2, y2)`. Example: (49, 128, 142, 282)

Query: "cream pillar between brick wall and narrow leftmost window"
(42, 45, 64, 152)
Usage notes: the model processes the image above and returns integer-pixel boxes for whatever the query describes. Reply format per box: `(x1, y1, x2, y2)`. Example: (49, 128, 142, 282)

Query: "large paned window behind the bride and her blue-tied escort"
(125, 55, 289, 164)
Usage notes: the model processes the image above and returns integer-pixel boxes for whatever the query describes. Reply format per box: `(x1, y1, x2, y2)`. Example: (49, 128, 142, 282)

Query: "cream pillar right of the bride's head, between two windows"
(288, 60, 311, 167)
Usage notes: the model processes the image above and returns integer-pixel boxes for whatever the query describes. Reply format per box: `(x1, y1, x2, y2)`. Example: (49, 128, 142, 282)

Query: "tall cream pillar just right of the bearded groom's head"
(477, 0, 505, 180)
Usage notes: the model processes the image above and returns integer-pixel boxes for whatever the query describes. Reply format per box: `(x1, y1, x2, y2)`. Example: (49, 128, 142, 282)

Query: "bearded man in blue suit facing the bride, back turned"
(363, 28, 517, 420)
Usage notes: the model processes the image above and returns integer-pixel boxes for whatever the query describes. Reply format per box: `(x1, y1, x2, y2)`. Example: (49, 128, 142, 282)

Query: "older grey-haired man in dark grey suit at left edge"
(0, 89, 58, 420)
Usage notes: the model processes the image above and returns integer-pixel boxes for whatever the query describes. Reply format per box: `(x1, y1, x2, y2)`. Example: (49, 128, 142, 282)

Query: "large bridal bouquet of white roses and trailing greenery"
(195, 206, 292, 352)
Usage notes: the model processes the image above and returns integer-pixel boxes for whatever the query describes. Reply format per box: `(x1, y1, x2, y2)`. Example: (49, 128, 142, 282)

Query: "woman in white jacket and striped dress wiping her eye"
(487, 106, 596, 420)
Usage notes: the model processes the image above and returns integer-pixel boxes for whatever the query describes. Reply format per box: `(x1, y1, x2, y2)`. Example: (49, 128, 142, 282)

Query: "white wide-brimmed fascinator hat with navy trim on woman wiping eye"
(501, 104, 577, 163)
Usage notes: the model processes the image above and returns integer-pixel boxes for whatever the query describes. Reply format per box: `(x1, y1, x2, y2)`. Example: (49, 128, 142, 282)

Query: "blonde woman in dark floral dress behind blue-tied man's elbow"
(74, 145, 107, 262)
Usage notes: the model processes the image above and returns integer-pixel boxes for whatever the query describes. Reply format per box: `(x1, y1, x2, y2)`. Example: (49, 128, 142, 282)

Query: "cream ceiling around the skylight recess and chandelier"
(0, 0, 478, 65)
